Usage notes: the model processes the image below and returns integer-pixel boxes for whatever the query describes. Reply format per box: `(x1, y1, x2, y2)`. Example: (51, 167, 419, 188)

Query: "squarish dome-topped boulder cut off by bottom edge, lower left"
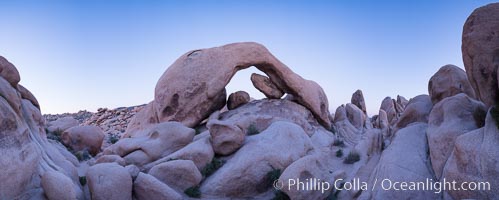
(86, 163, 132, 200)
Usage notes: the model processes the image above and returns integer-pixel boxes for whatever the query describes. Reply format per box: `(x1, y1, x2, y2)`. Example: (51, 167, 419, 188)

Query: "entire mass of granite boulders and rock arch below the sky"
(0, 3, 499, 200)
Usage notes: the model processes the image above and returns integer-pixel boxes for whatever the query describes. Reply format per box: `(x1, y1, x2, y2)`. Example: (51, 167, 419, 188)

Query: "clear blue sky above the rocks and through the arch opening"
(0, 0, 491, 115)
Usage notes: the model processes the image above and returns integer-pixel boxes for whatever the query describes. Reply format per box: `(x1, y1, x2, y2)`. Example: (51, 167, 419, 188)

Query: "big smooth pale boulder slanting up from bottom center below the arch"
(201, 122, 312, 198)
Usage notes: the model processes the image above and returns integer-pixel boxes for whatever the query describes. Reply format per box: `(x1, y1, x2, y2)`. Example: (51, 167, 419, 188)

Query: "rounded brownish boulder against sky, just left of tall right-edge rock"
(428, 65, 476, 105)
